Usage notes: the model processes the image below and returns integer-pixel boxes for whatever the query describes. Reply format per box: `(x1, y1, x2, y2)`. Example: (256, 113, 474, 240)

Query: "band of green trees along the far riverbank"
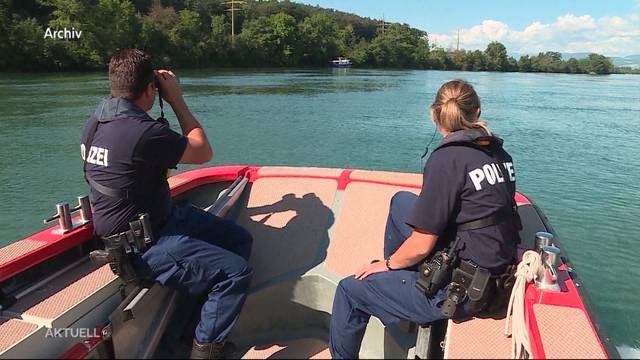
(0, 0, 626, 74)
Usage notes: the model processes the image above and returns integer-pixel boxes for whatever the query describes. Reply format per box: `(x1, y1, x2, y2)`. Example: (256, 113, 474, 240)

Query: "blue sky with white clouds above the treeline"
(297, 0, 640, 56)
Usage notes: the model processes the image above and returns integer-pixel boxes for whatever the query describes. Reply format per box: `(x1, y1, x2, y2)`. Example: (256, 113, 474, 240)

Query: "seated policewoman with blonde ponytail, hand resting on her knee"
(329, 80, 517, 358)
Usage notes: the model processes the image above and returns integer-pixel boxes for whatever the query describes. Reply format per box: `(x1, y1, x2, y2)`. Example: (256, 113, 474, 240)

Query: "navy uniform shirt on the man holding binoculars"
(80, 98, 187, 236)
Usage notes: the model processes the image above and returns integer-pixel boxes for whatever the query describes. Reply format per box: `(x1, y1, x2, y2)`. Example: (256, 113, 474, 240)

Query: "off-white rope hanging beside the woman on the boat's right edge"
(504, 250, 542, 359)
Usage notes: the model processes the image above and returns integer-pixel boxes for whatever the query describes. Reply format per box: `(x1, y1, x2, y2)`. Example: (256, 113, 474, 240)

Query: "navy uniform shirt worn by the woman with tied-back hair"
(407, 129, 517, 271)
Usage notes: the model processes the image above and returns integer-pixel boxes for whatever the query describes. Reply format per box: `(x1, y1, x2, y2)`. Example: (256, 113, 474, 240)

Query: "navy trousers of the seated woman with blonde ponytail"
(329, 192, 446, 359)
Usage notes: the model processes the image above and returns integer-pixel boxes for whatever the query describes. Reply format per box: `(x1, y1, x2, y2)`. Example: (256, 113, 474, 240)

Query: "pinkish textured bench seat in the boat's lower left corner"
(0, 260, 120, 358)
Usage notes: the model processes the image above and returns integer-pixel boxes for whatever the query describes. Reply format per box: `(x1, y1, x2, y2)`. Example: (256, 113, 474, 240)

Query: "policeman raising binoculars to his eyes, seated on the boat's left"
(81, 49, 252, 359)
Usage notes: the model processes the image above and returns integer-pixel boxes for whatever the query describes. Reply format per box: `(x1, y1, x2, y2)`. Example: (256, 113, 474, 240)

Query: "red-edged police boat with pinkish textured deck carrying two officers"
(0, 166, 619, 359)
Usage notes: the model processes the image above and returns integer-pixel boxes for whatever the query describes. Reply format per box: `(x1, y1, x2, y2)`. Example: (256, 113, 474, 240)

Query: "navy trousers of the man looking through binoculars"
(135, 206, 253, 343)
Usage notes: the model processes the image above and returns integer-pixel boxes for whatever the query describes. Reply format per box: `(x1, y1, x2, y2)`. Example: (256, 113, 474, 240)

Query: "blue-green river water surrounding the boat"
(0, 69, 640, 356)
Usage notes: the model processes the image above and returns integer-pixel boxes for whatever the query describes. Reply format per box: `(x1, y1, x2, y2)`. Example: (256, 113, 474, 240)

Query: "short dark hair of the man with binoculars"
(109, 49, 154, 100)
